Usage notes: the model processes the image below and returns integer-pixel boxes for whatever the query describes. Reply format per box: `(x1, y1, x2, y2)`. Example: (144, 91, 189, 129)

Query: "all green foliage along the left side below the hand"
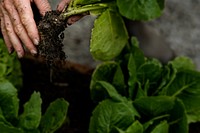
(0, 40, 69, 133)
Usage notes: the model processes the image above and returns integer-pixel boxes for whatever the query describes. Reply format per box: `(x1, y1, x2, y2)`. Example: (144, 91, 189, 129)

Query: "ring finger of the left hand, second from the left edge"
(1, 4, 24, 58)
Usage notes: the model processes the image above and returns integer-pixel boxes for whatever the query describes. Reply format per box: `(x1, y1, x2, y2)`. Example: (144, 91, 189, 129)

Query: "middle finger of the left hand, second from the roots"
(3, 2, 37, 55)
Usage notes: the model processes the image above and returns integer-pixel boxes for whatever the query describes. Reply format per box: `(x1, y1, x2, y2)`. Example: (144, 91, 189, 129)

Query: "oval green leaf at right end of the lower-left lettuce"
(40, 99, 69, 133)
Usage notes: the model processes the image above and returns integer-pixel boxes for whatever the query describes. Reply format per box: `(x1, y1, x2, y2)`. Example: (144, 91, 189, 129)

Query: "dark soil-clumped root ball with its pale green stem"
(37, 4, 107, 66)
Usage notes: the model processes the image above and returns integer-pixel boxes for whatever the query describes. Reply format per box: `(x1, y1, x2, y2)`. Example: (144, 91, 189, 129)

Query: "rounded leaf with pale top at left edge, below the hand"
(0, 80, 19, 120)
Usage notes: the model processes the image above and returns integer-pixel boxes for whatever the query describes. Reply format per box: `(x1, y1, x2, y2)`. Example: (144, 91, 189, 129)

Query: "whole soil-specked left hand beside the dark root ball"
(0, 0, 51, 58)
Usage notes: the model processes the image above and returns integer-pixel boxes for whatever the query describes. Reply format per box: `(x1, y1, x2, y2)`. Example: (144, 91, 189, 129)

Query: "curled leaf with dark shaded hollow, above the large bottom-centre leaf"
(91, 81, 124, 101)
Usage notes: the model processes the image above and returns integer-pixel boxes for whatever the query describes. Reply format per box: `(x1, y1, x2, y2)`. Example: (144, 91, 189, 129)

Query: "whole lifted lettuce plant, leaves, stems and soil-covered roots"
(38, 0, 164, 61)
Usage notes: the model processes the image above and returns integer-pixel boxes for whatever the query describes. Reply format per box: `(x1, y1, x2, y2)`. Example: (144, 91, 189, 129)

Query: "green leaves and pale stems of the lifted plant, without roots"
(67, 0, 164, 61)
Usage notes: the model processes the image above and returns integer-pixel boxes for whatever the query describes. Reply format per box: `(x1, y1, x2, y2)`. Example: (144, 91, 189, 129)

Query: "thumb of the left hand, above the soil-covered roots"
(34, 0, 51, 16)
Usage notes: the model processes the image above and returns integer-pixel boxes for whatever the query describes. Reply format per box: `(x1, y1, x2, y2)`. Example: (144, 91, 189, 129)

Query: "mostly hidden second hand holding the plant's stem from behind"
(57, 0, 86, 25)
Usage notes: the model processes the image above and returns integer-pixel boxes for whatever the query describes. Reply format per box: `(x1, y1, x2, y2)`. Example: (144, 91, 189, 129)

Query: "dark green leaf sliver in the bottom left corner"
(0, 122, 24, 133)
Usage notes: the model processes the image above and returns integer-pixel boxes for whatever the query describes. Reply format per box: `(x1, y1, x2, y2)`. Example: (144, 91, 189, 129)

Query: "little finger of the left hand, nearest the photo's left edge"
(1, 17, 13, 53)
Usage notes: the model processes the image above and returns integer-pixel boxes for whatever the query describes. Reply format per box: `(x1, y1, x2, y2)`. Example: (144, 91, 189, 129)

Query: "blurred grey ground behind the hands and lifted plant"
(49, 0, 200, 70)
